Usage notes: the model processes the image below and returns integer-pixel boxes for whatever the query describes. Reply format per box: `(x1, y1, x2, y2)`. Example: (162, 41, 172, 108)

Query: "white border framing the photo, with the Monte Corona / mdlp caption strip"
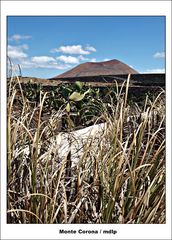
(1, 1, 172, 240)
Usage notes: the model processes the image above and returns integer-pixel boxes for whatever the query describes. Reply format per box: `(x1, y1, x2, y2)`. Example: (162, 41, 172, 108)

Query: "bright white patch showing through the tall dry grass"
(15, 123, 107, 167)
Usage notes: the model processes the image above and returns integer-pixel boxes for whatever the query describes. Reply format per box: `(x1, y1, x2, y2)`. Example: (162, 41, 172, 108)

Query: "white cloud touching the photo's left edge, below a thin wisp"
(7, 44, 28, 59)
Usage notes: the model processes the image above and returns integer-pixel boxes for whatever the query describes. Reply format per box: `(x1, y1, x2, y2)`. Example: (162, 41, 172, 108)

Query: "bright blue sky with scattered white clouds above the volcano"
(7, 16, 165, 78)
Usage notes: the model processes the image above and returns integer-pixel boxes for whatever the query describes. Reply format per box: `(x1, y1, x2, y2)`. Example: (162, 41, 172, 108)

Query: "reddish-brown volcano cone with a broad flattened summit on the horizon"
(55, 59, 138, 78)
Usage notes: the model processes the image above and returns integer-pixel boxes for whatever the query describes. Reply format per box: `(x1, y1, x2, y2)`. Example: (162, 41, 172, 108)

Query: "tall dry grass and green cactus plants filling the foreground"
(7, 74, 166, 224)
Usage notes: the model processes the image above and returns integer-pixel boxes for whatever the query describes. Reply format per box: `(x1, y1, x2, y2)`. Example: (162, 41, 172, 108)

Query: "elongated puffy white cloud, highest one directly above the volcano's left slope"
(51, 45, 96, 55)
